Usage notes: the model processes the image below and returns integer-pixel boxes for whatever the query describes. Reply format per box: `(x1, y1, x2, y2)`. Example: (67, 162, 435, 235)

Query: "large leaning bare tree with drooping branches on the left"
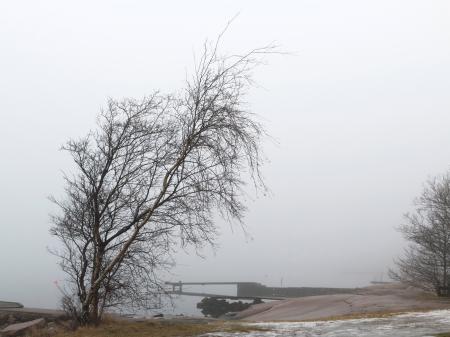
(51, 38, 274, 324)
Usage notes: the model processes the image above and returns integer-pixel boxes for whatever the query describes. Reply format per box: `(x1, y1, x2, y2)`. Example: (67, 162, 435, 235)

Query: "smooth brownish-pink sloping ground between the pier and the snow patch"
(236, 283, 450, 321)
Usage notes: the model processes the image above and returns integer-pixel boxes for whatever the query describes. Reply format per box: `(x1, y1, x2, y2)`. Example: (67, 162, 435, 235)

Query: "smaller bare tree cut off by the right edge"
(390, 174, 450, 296)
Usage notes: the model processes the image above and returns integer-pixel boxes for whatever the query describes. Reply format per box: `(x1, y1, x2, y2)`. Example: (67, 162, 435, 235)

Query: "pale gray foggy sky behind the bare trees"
(0, 0, 450, 306)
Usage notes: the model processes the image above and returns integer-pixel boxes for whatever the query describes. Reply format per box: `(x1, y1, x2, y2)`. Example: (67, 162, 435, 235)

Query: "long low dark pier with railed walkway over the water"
(166, 281, 356, 300)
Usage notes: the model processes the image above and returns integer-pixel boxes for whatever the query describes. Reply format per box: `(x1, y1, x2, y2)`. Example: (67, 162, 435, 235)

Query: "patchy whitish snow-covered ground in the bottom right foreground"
(205, 310, 450, 337)
